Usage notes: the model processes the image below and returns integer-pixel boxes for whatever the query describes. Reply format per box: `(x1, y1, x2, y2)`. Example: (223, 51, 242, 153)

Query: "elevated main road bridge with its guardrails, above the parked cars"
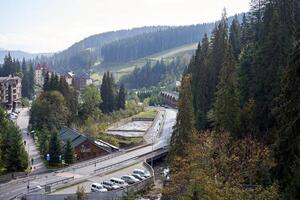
(0, 109, 177, 200)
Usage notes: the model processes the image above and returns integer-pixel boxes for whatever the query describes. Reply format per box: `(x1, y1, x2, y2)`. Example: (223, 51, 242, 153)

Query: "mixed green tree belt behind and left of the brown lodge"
(30, 72, 126, 165)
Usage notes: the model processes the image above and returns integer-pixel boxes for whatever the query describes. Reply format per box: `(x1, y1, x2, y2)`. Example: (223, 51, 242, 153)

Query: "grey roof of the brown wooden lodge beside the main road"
(59, 127, 117, 152)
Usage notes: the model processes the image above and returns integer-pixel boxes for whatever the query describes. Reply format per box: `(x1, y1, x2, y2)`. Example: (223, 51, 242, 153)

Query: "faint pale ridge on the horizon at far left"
(0, 48, 53, 63)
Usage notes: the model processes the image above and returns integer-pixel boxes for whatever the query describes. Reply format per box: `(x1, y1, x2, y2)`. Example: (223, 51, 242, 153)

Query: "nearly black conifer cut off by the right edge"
(274, 31, 300, 199)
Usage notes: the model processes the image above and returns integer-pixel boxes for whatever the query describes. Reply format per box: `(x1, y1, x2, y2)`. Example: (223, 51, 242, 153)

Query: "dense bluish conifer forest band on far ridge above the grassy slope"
(102, 15, 242, 62)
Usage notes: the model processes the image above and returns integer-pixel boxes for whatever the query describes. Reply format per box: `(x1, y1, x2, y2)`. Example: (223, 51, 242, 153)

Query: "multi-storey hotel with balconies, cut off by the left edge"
(0, 76, 22, 109)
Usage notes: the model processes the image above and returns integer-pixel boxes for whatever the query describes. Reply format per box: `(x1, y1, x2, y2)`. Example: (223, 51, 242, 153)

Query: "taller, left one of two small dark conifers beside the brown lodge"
(49, 132, 62, 165)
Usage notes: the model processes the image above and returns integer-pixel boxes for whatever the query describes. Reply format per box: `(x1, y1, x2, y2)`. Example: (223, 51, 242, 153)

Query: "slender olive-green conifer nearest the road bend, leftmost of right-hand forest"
(171, 74, 195, 157)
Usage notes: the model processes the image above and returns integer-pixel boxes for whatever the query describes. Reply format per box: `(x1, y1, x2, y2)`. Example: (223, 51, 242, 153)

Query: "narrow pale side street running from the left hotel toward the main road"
(17, 108, 47, 174)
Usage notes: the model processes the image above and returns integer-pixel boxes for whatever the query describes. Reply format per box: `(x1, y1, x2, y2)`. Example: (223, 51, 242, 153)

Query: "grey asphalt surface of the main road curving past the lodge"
(0, 109, 177, 200)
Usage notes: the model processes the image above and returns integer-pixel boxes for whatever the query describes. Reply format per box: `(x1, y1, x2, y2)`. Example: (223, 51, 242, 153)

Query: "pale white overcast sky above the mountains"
(0, 0, 250, 53)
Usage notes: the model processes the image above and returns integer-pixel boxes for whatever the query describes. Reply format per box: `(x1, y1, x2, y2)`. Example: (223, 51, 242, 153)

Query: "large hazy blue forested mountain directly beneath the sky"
(39, 14, 242, 72)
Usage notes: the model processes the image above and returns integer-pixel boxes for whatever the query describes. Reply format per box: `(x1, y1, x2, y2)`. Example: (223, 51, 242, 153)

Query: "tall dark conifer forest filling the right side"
(168, 0, 300, 199)
